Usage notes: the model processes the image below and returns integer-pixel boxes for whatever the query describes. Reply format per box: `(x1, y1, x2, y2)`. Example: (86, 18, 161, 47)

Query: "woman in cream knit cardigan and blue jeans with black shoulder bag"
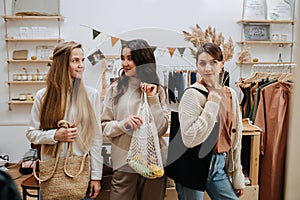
(176, 43, 245, 200)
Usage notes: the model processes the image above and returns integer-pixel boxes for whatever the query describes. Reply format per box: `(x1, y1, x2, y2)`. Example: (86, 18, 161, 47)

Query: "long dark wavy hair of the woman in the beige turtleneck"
(114, 39, 159, 104)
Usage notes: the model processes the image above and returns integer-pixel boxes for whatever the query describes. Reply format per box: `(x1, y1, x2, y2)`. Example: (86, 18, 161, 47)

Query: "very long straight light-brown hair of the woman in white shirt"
(40, 41, 99, 154)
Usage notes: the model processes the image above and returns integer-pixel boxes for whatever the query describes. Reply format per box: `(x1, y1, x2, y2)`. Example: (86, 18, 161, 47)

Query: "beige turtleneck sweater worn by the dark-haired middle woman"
(101, 77, 168, 169)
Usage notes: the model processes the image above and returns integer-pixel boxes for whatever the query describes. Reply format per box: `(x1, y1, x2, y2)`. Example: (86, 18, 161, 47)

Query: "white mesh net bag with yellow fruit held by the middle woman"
(127, 93, 164, 179)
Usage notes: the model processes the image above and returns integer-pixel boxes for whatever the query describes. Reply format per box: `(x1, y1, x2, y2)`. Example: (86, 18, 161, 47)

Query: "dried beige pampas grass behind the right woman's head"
(182, 24, 234, 61)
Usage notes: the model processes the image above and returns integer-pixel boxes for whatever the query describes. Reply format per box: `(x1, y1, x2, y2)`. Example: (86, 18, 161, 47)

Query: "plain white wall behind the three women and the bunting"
(0, 0, 298, 162)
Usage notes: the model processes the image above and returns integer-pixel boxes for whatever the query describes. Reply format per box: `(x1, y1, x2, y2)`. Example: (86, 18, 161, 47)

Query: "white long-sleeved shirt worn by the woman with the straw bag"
(26, 86, 103, 180)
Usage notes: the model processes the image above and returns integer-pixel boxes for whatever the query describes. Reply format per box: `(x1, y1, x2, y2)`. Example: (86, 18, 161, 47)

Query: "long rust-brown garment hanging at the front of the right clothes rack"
(255, 82, 293, 200)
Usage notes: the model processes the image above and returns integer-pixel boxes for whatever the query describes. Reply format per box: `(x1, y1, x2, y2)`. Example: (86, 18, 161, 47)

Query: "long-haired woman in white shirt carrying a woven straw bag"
(26, 41, 103, 198)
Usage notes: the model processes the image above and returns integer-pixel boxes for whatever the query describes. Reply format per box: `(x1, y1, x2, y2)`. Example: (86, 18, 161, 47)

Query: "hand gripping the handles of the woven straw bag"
(54, 124, 78, 142)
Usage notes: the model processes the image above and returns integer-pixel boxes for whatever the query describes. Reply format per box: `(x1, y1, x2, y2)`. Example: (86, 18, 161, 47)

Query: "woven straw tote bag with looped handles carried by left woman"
(33, 120, 90, 200)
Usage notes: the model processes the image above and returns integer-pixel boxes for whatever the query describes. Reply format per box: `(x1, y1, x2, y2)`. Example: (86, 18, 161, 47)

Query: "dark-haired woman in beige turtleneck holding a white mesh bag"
(101, 39, 168, 200)
